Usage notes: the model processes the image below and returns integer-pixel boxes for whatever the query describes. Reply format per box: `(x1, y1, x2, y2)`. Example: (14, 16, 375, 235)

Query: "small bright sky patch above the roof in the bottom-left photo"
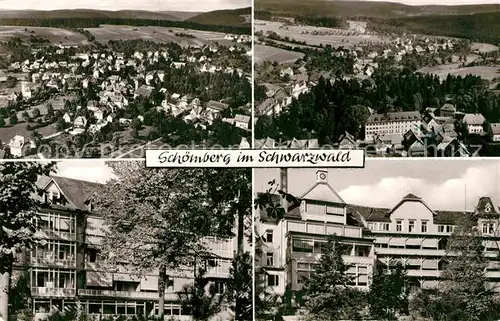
(55, 160, 115, 183)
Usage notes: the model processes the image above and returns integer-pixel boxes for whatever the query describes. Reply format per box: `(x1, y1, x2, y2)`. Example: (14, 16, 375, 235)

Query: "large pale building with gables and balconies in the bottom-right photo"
(257, 169, 500, 295)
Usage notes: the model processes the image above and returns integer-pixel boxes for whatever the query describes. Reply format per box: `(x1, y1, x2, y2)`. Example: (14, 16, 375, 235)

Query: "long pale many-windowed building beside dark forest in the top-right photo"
(365, 111, 422, 141)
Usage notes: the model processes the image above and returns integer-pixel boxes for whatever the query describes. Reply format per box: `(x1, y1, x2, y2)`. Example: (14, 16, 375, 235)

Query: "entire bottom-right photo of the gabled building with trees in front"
(254, 162, 500, 321)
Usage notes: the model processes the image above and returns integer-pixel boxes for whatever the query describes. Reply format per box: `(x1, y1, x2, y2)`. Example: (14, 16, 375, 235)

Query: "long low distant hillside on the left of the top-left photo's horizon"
(0, 9, 184, 21)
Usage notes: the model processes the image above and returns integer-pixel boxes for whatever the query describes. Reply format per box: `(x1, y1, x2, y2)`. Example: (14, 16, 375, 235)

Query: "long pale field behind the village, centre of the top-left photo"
(86, 25, 231, 47)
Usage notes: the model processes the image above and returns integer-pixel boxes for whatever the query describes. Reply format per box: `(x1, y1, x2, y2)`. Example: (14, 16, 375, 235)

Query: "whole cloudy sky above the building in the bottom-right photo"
(254, 158, 500, 211)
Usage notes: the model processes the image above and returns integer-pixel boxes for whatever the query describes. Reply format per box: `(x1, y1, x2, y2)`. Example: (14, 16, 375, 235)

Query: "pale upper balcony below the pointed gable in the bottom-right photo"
(286, 221, 363, 238)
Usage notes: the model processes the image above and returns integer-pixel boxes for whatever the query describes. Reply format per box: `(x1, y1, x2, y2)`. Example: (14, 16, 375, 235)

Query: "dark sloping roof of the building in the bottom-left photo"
(37, 176, 102, 211)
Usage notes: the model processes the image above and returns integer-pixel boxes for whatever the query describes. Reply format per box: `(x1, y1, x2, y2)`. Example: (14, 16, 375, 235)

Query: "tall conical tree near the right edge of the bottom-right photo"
(440, 214, 495, 321)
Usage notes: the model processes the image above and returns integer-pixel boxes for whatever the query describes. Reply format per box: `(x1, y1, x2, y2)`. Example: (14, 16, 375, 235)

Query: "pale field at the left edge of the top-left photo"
(0, 26, 87, 45)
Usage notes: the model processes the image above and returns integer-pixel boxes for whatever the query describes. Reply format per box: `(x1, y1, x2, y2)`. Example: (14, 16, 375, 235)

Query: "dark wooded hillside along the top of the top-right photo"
(255, 0, 500, 18)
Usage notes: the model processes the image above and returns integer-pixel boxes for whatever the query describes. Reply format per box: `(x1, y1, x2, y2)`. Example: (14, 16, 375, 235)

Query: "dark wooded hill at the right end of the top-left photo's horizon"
(187, 7, 252, 27)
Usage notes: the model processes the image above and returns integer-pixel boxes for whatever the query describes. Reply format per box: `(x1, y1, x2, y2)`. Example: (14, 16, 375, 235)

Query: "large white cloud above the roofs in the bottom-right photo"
(339, 165, 499, 211)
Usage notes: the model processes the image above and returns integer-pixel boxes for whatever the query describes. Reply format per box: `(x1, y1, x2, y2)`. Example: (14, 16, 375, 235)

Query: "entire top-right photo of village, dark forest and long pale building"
(254, 0, 500, 157)
